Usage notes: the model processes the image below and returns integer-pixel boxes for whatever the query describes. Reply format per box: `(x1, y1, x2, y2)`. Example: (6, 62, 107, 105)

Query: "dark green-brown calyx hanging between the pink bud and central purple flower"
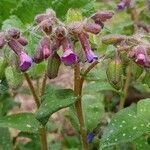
(47, 52, 61, 79)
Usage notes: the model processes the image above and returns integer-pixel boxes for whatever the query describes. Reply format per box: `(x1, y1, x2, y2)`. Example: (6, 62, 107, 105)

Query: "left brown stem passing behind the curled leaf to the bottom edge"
(24, 73, 48, 150)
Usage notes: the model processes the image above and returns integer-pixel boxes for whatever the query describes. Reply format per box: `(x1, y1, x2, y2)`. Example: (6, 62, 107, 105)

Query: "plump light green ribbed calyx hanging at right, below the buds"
(106, 58, 123, 90)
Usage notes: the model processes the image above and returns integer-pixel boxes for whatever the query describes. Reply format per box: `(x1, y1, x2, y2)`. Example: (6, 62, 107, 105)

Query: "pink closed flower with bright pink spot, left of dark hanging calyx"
(33, 36, 52, 63)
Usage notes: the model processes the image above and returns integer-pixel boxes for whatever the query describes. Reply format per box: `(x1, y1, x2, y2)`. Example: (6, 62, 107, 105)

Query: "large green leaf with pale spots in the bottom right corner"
(101, 99, 150, 148)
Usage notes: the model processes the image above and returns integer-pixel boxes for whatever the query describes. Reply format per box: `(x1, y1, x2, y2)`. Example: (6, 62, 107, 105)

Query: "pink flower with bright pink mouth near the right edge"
(129, 45, 147, 66)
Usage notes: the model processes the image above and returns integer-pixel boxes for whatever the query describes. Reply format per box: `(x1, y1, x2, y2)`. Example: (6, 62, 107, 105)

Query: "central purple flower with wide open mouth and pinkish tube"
(61, 37, 77, 65)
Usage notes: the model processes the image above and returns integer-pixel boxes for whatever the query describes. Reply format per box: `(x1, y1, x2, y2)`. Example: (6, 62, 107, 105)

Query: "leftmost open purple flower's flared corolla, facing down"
(18, 52, 32, 72)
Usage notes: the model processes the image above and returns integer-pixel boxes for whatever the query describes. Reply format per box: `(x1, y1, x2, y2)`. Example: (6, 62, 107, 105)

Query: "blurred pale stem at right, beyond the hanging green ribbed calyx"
(118, 64, 131, 110)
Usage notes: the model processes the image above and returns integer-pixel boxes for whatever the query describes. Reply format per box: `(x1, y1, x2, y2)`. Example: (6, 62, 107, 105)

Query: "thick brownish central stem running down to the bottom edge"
(74, 63, 88, 150)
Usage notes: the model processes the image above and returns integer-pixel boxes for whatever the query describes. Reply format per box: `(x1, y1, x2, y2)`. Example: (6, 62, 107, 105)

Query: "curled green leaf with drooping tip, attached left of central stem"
(36, 86, 76, 125)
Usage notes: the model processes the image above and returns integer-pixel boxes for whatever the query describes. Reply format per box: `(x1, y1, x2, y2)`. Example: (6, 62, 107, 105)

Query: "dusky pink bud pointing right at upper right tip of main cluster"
(91, 11, 114, 25)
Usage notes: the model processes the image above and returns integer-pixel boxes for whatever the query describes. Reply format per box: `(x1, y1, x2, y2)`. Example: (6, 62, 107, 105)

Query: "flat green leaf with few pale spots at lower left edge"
(0, 113, 41, 132)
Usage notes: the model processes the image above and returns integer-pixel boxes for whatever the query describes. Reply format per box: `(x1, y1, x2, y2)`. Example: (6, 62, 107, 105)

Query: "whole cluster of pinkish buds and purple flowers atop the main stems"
(0, 9, 114, 72)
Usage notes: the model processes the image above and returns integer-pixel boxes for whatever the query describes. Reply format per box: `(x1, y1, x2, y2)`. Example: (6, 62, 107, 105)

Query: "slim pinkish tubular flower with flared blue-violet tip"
(78, 33, 98, 63)
